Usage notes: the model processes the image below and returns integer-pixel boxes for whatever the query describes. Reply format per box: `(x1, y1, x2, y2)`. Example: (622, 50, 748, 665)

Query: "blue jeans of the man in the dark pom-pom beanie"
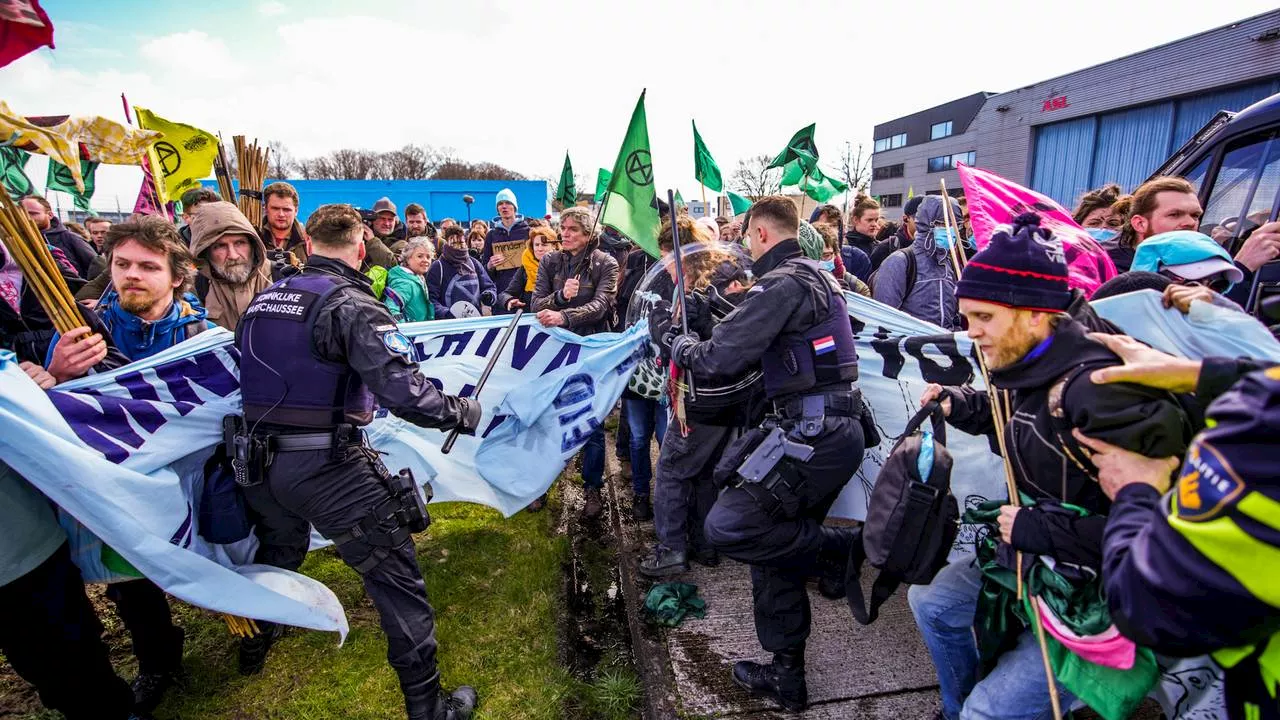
(906, 560, 1074, 720)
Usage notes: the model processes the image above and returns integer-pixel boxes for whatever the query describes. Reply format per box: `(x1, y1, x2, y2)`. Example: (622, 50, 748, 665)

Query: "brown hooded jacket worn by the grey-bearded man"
(191, 201, 271, 331)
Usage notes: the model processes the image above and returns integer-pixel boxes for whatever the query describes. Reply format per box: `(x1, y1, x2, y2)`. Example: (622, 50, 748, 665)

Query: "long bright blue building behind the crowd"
(205, 179, 552, 223)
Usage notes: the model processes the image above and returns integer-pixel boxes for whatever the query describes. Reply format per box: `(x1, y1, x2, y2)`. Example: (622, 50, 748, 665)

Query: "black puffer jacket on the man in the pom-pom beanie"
(946, 320, 1194, 568)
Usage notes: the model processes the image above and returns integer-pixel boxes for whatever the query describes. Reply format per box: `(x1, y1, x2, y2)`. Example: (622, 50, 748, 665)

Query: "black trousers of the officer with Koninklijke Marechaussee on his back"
(244, 447, 435, 685)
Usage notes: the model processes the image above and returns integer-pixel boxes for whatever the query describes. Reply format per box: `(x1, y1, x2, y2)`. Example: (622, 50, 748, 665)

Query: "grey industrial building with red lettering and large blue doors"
(870, 10, 1280, 217)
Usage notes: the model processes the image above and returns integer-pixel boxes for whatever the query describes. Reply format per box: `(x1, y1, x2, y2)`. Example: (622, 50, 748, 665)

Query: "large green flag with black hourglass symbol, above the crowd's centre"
(600, 92, 660, 258)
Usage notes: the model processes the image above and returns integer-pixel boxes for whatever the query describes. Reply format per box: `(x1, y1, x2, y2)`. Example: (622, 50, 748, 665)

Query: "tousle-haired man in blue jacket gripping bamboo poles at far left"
(45, 215, 206, 712)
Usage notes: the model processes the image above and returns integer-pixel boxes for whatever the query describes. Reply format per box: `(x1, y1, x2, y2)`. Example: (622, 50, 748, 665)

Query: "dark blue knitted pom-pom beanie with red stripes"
(956, 213, 1073, 313)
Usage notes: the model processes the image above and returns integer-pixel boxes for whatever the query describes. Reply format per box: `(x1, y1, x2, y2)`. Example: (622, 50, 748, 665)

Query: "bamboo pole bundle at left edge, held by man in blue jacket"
(0, 190, 84, 334)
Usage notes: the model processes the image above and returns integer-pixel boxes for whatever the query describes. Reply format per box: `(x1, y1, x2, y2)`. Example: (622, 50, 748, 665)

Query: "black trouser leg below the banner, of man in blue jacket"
(106, 578, 183, 674)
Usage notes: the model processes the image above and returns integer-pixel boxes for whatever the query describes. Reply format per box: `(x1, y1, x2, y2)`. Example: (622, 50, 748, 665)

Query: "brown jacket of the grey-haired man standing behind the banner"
(532, 240, 618, 336)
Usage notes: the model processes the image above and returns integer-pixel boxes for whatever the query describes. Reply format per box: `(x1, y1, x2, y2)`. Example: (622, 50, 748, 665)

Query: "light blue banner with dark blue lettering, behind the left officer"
(0, 316, 646, 634)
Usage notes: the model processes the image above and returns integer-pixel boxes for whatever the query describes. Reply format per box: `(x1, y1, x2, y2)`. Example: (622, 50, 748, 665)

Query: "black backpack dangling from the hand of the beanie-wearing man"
(845, 401, 960, 625)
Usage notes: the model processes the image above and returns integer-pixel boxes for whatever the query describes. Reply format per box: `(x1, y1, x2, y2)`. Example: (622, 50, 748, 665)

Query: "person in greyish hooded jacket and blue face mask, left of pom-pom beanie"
(870, 195, 959, 331)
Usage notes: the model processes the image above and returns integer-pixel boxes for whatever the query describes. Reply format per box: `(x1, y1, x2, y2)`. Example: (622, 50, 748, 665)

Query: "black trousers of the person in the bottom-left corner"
(0, 543, 133, 720)
